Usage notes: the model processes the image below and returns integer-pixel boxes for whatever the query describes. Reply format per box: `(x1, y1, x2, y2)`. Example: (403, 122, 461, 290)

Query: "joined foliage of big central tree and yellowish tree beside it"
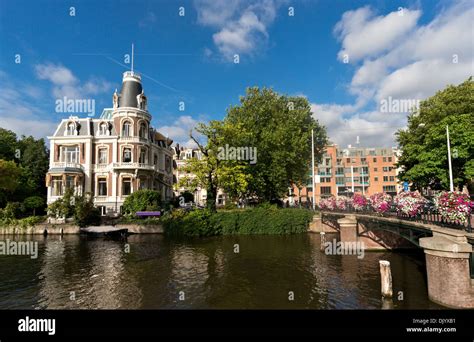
(183, 87, 327, 208)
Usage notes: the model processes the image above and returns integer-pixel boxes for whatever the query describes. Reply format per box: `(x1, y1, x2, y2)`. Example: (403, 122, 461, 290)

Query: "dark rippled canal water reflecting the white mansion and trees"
(0, 233, 442, 309)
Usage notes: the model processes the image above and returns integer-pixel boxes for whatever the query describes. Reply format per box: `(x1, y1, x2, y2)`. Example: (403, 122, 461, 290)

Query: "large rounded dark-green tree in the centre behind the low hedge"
(224, 87, 327, 201)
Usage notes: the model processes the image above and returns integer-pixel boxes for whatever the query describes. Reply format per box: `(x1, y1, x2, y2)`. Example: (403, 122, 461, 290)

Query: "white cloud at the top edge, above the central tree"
(195, 0, 280, 59)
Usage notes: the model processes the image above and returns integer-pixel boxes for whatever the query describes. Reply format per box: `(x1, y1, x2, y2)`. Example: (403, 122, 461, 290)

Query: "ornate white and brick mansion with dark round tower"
(46, 71, 173, 214)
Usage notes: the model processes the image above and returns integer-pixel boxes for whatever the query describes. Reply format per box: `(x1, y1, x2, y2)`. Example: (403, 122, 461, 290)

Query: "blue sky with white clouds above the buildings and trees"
(0, 0, 474, 146)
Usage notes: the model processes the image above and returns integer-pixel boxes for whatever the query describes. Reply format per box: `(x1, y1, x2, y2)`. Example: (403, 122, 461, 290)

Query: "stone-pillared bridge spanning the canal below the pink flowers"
(309, 211, 474, 309)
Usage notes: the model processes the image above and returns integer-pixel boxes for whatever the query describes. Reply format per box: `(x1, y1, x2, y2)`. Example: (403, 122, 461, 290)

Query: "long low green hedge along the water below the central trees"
(163, 206, 314, 236)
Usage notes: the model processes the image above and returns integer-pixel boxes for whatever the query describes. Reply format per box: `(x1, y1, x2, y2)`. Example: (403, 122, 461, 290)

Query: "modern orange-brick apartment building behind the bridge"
(292, 145, 401, 203)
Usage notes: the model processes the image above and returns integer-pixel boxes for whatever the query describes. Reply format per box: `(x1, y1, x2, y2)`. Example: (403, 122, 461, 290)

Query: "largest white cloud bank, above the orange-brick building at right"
(312, 1, 474, 146)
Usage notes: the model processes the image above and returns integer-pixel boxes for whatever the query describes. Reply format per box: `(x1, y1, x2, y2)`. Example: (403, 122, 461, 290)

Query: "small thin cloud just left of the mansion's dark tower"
(35, 63, 112, 98)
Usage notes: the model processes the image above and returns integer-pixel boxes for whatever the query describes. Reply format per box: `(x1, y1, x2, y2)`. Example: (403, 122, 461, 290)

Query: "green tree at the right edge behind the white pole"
(396, 77, 474, 189)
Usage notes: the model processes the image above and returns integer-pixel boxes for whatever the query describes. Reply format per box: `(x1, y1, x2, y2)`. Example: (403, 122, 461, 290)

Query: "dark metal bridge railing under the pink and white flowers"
(321, 203, 474, 232)
